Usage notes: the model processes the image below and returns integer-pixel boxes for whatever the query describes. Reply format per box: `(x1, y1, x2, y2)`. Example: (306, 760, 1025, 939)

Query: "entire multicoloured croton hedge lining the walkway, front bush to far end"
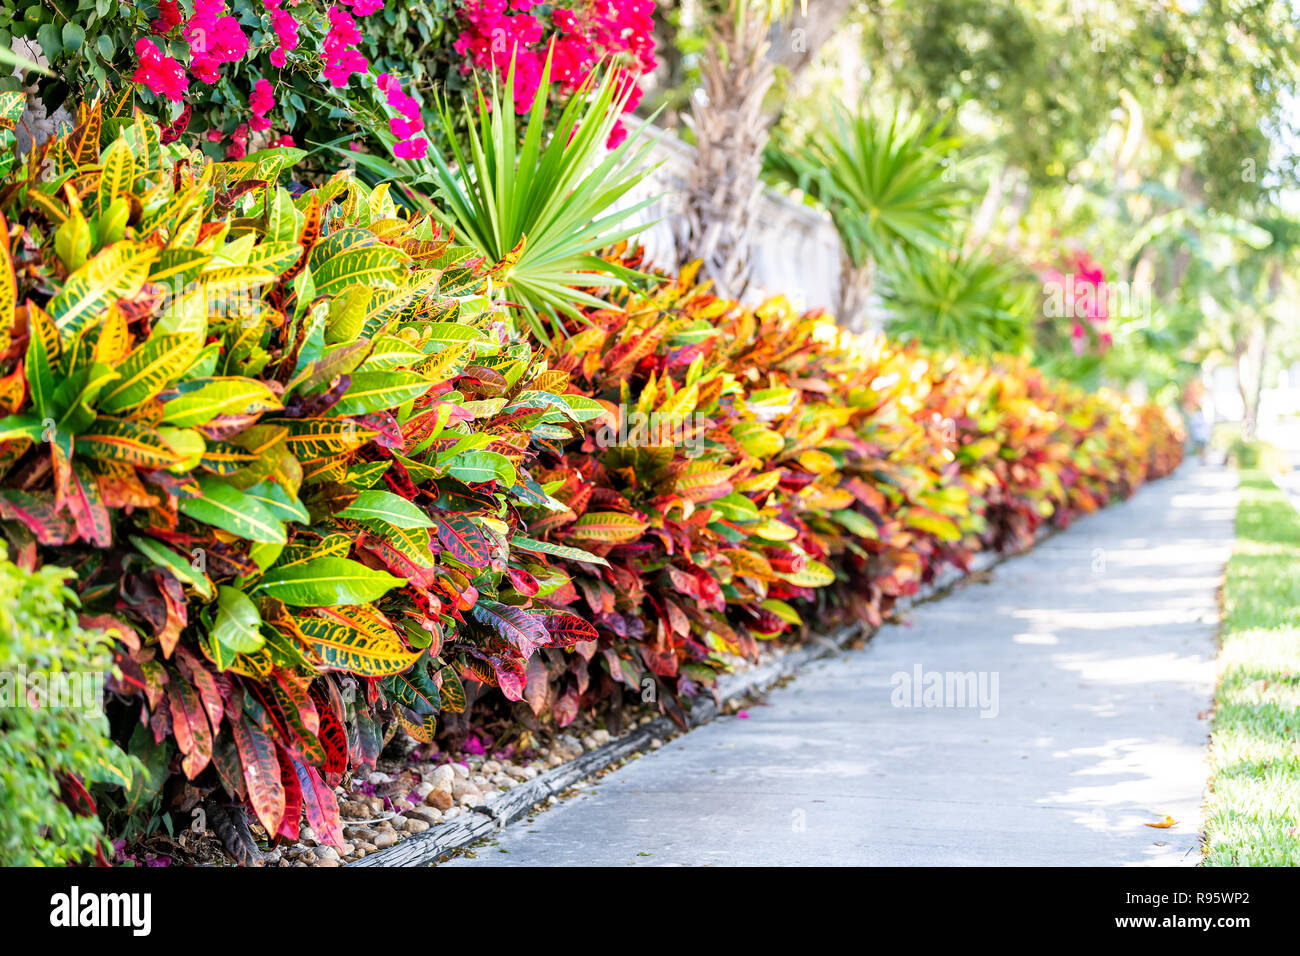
(0, 95, 1179, 862)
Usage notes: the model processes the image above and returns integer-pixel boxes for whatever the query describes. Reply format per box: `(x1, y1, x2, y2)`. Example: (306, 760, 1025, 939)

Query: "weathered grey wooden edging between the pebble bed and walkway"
(345, 538, 1019, 866)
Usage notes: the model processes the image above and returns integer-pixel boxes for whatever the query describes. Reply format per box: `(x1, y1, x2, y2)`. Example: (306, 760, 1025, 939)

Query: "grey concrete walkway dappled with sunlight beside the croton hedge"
(446, 462, 1236, 866)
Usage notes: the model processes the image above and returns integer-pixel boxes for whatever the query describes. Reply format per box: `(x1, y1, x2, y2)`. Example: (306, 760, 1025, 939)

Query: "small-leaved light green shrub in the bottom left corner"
(0, 545, 134, 866)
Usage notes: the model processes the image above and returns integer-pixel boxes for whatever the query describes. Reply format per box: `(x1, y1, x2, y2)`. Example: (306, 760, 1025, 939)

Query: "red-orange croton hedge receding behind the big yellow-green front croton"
(496, 251, 1182, 724)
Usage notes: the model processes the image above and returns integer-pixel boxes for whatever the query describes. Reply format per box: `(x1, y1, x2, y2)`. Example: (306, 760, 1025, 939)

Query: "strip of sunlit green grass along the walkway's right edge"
(1205, 471, 1300, 866)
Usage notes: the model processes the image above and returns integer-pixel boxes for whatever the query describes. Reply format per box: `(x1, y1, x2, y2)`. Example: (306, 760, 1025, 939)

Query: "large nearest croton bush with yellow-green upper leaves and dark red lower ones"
(0, 95, 613, 860)
